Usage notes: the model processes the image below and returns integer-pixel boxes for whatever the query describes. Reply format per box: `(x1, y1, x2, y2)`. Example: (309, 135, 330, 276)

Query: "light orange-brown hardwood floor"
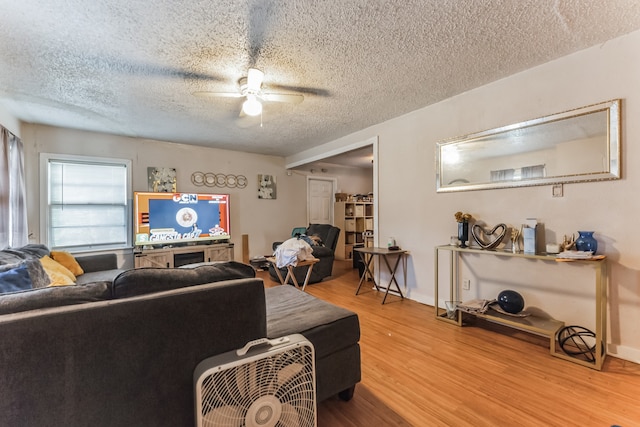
(258, 261, 640, 427)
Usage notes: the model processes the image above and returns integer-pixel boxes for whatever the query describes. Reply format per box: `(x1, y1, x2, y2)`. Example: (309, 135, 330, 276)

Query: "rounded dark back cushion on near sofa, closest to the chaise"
(113, 261, 256, 298)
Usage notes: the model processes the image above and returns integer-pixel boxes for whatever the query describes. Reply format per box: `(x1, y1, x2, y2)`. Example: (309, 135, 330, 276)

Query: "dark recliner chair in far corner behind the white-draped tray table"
(269, 224, 340, 283)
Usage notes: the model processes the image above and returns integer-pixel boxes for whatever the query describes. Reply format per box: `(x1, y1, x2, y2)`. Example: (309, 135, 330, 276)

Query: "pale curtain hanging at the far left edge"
(0, 126, 28, 248)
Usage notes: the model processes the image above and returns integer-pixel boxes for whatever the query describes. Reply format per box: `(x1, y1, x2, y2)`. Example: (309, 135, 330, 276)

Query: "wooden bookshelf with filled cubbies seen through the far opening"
(333, 202, 373, 260)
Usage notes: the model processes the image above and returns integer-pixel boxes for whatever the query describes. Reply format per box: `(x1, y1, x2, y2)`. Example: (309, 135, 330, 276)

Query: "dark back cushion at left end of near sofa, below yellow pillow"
(0, 282, 111, 315)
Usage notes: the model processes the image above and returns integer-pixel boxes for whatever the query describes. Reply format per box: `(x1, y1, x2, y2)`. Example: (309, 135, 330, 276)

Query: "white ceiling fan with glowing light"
(193, 68, 304, 116)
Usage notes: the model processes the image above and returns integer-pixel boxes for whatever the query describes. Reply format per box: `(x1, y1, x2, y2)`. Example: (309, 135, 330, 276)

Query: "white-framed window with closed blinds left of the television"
(40, 154, 131, 251)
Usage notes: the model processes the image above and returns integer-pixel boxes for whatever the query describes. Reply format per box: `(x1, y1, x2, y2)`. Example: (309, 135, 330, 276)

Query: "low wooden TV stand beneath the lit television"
(134, 243, 233, 268)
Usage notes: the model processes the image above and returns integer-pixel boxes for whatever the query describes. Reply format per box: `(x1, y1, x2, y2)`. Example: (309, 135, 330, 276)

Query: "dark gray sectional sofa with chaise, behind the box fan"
(0, 246, 360, 426)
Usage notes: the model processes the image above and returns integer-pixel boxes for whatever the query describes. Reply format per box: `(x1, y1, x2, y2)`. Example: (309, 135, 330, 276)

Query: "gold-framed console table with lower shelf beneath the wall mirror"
(434, 245, 608, 370)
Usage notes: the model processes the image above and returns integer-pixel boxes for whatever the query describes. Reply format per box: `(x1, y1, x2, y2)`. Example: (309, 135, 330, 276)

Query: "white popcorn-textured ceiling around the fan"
(0, 0, 640, 156)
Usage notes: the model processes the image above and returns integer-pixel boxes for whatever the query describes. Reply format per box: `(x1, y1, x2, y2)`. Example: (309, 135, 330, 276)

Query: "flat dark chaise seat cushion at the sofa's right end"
(265, 285, 360, 359)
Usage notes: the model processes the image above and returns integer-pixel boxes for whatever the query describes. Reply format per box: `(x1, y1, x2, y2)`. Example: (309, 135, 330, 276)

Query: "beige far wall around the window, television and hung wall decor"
(22, 124, 306, 266)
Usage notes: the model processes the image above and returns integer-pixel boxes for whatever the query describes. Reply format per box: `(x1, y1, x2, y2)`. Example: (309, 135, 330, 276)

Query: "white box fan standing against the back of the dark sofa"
(193, 334, 317, 427)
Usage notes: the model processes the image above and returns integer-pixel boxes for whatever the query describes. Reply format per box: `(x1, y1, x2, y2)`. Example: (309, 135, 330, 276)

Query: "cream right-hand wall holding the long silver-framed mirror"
(287, 32, 640, 362)
